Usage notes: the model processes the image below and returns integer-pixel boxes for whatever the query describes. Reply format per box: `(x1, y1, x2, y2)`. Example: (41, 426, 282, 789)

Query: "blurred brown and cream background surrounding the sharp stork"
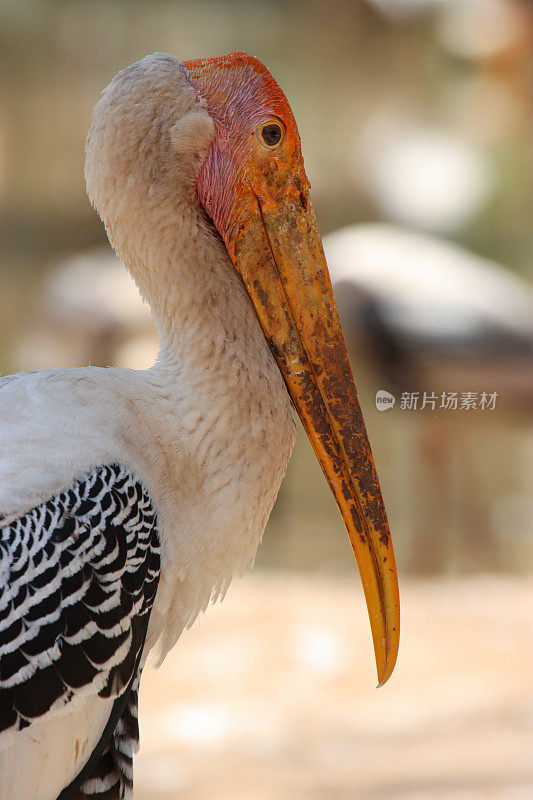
(0, 0, 533, 800)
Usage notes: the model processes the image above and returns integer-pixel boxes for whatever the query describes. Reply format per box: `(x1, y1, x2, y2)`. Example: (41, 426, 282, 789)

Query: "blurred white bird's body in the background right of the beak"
(324, 224, 533, 360)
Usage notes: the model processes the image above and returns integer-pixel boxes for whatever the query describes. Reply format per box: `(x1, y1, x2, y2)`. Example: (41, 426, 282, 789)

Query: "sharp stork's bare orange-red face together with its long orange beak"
(182, 53, 400, 686)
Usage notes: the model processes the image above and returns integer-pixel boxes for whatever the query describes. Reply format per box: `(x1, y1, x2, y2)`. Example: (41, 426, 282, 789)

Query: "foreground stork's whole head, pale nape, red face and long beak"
(86, 53, 399, 685)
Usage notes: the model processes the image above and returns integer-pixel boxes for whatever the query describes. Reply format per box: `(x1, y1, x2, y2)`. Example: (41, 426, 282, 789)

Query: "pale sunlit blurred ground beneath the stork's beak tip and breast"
(135, 573, 533, 800)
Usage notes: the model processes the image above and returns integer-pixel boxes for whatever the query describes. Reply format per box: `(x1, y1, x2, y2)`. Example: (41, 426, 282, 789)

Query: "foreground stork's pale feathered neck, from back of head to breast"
(85, 55, 295, 651)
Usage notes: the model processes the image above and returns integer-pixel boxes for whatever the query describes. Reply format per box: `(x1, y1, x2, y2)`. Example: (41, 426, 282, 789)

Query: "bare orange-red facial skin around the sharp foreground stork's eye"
(181, 53, 307, 254)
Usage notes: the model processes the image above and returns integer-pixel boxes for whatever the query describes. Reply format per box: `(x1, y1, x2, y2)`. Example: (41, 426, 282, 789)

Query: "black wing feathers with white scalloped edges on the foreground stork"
(0, 465, 160, 796)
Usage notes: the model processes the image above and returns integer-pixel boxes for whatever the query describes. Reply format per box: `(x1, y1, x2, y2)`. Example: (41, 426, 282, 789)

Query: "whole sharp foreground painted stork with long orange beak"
(0, 53, 399, 800)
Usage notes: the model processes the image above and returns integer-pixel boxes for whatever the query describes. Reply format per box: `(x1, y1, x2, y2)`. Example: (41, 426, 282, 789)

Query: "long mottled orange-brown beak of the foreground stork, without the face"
(231, 182, 400, 686)
